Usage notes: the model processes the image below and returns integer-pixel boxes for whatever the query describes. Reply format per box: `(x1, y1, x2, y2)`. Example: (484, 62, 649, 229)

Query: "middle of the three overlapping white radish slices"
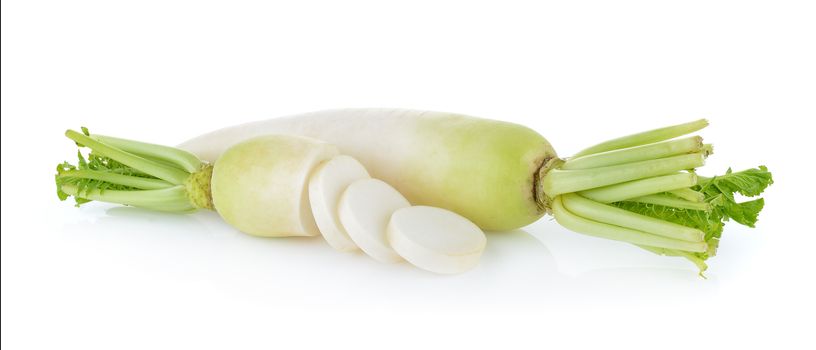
(337, 179, 411, 262)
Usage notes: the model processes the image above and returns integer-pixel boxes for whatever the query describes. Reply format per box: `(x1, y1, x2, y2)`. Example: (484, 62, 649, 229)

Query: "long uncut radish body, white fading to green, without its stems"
(180, 109, 557, 230)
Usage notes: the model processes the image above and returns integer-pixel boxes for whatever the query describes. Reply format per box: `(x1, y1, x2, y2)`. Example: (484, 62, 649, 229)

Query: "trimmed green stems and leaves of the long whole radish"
(538, 120, 773, 274)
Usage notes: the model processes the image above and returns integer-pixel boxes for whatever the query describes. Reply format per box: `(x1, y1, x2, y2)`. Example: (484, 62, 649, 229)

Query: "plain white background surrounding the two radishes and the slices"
(2, 0, 816, 349)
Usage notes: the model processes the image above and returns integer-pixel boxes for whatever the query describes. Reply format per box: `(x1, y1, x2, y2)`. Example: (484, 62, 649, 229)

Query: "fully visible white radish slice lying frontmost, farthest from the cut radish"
(387, 206, 487, 274)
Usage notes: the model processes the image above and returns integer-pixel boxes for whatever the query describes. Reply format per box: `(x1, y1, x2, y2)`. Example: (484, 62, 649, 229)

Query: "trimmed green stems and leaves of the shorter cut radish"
(55, 127, 213, 212)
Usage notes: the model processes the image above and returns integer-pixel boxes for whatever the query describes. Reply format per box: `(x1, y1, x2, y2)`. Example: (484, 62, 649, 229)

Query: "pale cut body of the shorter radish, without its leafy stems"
(212, 135, 339, 237)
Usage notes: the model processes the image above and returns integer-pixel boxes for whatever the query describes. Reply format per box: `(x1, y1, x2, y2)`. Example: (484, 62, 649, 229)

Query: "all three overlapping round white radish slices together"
(308, 155, 487, 274)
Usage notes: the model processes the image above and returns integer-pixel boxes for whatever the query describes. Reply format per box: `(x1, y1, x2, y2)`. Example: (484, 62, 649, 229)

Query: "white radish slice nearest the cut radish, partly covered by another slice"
(309, 155, 370, 251)
